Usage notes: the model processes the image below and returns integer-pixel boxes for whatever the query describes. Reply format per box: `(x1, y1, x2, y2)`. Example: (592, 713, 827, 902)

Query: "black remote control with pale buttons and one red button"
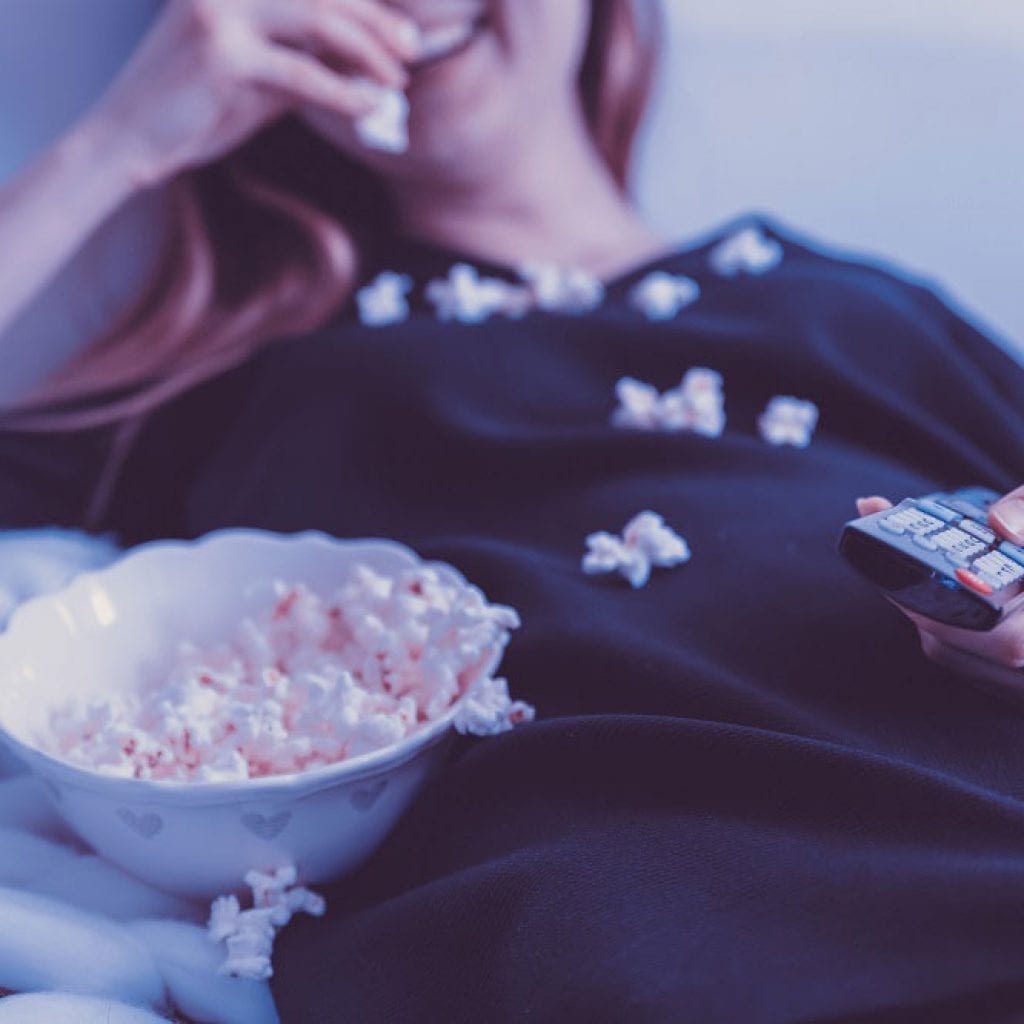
(839, 487, 1024, 630)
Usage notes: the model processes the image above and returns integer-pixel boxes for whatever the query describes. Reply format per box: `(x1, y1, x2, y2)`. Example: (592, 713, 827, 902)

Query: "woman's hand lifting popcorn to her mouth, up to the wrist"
(79, 0, 417, 188)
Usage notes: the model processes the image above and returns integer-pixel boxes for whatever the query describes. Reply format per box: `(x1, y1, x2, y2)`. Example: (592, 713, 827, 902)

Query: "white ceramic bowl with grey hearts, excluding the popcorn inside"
(0, 529, 512, 897)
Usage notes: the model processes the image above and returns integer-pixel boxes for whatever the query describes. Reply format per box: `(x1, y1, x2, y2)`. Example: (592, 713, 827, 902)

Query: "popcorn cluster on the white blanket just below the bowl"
(207, 865, 327, 980)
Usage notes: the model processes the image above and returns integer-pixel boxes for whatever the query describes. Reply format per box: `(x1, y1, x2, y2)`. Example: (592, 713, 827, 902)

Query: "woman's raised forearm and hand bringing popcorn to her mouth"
(0, 0, 416, 346)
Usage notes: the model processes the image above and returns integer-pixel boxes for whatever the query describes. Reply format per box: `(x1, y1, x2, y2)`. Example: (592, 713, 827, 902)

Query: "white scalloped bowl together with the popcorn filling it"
(0, 528, 532, 899)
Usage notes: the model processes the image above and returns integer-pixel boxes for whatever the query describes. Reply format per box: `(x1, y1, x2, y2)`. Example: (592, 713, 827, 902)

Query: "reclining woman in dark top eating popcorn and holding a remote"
(0, 0, 1024, 1024)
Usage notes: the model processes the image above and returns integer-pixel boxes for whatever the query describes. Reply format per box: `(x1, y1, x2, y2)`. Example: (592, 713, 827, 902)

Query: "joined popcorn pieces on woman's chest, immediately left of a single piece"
(611, 367, 726, 437)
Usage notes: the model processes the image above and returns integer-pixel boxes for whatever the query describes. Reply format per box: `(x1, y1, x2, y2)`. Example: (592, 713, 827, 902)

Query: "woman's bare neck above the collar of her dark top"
(393, 114, 667, 280)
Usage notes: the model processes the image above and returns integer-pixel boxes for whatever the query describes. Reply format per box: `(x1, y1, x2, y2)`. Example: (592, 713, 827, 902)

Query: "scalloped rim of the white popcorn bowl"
(0, 527, 505, 804)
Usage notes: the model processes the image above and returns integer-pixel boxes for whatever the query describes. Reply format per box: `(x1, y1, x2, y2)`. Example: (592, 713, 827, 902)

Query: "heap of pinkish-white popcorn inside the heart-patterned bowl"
(41, 566, 534, 781)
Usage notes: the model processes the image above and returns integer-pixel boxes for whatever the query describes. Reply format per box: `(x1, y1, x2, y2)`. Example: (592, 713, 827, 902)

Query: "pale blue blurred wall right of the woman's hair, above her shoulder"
(639, 0, 1024, 352)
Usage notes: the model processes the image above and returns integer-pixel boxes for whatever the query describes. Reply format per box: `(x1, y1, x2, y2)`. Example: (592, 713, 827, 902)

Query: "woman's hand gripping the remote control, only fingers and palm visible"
(857, 486, 1024, 697)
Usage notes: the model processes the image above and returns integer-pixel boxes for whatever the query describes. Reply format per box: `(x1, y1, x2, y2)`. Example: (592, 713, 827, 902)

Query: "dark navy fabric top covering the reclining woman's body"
(4, 214, 1024, 1024)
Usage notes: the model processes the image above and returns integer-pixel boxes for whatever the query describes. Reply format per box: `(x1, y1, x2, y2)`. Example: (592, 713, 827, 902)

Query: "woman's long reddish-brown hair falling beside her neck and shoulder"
(3, 0, 658, 440)
